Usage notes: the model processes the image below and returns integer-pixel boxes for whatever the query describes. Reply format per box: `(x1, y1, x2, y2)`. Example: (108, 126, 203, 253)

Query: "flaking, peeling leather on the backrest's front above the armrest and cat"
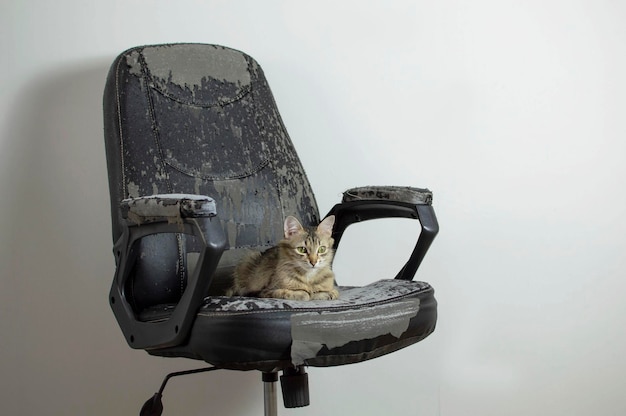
(107, 45, 319, 248)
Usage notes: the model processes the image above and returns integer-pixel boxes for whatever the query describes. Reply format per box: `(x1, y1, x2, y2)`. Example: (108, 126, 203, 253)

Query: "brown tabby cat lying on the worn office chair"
(228, 215, 339, 300)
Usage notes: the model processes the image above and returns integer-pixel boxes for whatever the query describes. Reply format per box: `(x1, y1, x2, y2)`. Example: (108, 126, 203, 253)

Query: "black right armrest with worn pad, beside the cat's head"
(328, 186, 439, 280)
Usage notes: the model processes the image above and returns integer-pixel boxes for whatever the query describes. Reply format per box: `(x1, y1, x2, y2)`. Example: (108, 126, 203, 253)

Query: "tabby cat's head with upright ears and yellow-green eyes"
(285, 215, 335, 269)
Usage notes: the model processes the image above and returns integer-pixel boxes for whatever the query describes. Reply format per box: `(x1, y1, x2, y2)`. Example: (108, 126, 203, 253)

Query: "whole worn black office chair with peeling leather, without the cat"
(104, 44, 438, 415)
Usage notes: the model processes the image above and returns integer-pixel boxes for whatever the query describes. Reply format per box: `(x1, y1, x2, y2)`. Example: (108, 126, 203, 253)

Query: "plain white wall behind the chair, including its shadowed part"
(0, 0, 626, 416)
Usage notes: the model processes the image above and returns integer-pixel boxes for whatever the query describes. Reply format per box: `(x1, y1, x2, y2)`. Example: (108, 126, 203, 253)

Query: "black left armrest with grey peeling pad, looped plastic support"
(109, 194, 227, 350)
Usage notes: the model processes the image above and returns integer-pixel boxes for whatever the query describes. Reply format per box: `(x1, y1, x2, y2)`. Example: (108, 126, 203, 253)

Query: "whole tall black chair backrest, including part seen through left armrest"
(104, 44, 319, 312)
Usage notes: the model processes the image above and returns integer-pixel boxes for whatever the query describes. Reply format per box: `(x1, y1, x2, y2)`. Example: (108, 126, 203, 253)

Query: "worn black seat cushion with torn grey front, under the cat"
(142, 279, 437, 371)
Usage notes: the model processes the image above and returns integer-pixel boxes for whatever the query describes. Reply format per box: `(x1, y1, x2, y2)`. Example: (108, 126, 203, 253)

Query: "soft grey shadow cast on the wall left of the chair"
(0, 58, 262, 414)
